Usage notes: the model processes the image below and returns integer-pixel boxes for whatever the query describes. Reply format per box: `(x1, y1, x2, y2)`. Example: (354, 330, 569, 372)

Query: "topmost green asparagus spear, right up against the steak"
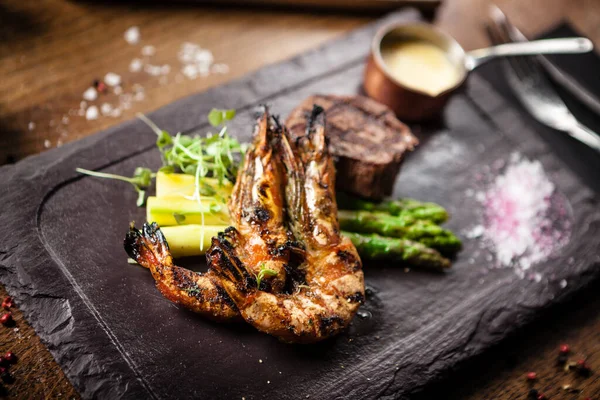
(337, 193, 448, 224)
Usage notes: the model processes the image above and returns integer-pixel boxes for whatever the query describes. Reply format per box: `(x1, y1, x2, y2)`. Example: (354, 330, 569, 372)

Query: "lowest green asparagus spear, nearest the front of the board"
(342, 231, 451, 269)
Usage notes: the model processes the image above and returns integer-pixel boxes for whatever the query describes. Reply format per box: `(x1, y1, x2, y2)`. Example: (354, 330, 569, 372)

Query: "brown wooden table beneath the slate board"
(0, 0, 600, 400)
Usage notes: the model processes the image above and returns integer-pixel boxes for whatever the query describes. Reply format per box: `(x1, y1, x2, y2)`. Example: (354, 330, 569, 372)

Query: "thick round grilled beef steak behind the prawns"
(286, 95, 418, 200)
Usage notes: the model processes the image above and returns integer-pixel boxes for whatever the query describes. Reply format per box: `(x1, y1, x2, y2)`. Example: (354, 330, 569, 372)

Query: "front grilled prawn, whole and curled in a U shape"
(207, 108, 364, 343)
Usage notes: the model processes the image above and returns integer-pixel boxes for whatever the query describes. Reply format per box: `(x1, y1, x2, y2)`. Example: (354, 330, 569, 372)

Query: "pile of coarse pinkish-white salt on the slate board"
(468, 153, 570, 276)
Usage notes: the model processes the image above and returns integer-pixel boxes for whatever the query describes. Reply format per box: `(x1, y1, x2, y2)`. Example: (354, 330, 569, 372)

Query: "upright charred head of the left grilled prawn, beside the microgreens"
(223, 107, 293, 292)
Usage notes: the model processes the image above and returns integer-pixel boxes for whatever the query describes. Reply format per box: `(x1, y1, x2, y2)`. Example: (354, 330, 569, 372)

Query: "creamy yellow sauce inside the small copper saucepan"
(381, 40, 461, 96)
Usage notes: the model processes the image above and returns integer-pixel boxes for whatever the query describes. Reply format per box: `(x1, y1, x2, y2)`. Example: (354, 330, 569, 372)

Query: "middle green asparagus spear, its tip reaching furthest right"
(338, 210, 462, 254)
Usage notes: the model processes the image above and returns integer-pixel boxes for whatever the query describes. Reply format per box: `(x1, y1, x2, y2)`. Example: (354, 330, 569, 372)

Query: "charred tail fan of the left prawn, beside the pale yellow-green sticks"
(123, 222, 173, 269)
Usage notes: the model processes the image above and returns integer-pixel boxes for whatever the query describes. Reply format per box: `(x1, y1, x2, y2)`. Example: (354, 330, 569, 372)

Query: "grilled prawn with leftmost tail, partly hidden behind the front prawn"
(124, 109, 290, 320)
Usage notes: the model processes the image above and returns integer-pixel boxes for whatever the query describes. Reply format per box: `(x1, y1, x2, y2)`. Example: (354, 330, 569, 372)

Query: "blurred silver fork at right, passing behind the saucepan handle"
(488, 9, 600, 152)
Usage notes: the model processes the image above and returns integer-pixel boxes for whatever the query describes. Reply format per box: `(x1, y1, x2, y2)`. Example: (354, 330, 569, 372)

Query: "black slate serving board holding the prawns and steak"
(0, 11, 600, 399)
